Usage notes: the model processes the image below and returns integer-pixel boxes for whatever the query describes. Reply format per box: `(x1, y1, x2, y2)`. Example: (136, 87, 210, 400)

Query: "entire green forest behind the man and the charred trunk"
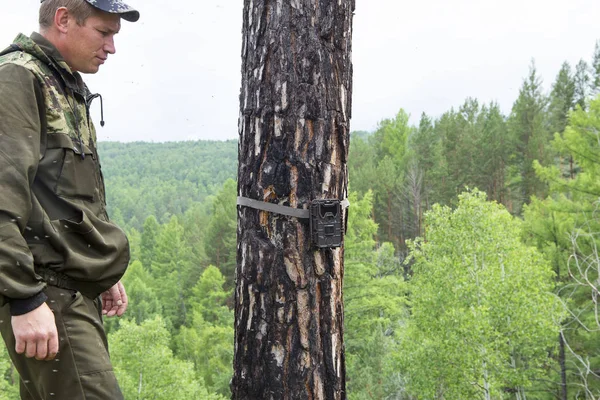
(0, 44, 600, 400)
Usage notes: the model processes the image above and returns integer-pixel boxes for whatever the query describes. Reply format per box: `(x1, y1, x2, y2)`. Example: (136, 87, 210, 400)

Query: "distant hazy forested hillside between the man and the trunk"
(99, 140, 237, 230)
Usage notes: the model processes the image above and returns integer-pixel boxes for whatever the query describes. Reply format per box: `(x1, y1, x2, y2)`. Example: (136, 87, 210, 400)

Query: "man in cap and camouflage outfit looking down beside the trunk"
(0, 0, 139, 400)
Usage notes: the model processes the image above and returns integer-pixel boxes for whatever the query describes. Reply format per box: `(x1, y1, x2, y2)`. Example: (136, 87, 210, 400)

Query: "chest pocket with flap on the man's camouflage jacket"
(45, 133, 98, 202)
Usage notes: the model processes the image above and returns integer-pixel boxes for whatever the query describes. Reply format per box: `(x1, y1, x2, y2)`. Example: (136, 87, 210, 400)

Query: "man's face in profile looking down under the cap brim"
(63, 12, 121, 74)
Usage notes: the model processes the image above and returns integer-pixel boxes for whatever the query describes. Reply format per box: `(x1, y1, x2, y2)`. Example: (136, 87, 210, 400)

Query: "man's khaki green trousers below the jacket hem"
(0, 286, 123, 400)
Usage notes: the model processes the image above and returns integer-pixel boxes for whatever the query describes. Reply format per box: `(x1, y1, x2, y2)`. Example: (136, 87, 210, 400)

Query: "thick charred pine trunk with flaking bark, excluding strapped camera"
(231, 0, 354, 400)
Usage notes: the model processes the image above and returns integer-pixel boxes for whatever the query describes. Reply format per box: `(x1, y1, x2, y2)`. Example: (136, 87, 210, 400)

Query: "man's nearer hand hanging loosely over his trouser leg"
(11, 303, 58, 361)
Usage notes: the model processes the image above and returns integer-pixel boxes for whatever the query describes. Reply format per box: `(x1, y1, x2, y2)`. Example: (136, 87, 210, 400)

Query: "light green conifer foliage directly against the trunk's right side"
(344, 191, 406, 399)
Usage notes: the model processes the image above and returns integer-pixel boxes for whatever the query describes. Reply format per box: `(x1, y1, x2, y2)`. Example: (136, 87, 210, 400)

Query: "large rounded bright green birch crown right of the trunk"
(397, 191, 560, 399)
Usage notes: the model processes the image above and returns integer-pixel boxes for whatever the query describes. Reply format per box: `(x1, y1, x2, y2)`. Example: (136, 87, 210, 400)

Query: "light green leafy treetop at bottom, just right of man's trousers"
(109, 317, 225, 400)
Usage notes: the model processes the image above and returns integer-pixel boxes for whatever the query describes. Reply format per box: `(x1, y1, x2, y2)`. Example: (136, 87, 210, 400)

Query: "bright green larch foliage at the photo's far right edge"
(524, 98, 600, 398)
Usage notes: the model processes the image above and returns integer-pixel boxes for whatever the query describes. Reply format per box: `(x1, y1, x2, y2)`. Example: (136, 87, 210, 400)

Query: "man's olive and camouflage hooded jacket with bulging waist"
(0, 33, 129, 315)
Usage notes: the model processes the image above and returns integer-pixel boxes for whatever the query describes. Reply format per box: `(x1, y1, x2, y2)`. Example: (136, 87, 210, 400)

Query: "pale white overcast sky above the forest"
(0, 0, 600, 141)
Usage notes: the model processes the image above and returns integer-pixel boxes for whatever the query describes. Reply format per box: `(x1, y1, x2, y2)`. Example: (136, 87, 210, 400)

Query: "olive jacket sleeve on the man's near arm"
(0, 64, 46, 315)
